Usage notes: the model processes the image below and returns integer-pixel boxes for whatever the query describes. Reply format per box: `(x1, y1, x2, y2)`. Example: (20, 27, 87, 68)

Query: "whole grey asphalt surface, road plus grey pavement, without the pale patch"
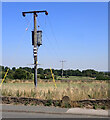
(1, 105, 109, 118)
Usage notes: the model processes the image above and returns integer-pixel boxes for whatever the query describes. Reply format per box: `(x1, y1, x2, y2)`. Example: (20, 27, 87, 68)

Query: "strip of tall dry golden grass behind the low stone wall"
(1, 80, 108, 101)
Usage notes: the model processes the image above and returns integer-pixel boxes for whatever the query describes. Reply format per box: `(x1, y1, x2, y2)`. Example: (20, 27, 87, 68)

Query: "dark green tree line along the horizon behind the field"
(0, 66, 110, 80)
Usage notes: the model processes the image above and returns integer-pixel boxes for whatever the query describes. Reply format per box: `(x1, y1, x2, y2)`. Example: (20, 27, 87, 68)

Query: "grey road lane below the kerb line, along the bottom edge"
(2, 112, 106, 118)
